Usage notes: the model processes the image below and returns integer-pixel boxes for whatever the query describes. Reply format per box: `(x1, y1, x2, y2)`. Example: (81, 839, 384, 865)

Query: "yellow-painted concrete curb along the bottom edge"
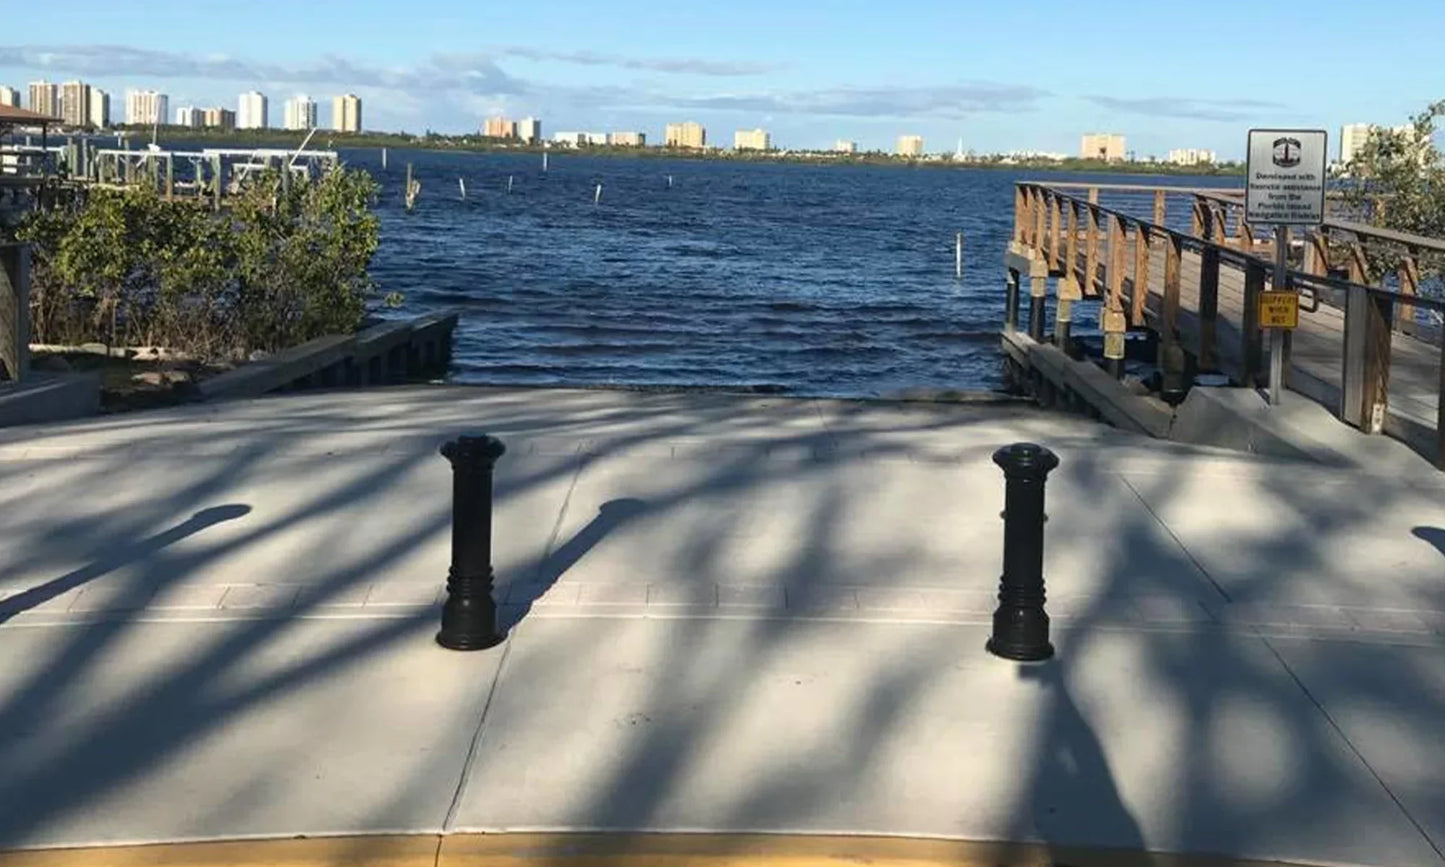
(0, 834, 1329, 867)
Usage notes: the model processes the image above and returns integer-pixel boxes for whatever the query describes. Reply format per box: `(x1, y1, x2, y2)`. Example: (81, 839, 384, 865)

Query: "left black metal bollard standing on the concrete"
(436, 434, 507, 650)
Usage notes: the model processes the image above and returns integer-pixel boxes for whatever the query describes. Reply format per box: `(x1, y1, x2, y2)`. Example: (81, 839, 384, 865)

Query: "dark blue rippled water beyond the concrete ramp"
(344, 150, 1219, 396)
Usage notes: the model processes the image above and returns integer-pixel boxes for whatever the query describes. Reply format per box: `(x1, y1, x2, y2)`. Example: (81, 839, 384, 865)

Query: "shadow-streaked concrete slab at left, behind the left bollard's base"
(0, 445, 581, 604)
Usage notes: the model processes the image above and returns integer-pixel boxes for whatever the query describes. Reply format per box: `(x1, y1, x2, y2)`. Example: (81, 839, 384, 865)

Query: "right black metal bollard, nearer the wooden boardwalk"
(988, 442, 1059, 662)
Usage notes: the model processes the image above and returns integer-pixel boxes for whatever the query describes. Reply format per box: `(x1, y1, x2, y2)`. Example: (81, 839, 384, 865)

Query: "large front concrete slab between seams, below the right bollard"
(452, 620, 1439, 867)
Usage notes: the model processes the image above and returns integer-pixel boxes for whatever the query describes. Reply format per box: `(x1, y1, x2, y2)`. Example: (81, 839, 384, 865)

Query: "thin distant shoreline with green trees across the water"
(109, 127, 1244, 178)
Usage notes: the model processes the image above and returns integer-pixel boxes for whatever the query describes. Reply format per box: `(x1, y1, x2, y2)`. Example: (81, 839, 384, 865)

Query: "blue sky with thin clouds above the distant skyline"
(0, 0, 1445, 159)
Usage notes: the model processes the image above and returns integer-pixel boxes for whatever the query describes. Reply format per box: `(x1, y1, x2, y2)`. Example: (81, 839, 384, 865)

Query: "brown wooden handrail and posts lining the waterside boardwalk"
(1004, 181, 1445, 470)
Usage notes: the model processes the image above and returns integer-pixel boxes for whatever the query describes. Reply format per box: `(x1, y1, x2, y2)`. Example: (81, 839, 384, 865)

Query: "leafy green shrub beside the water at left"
(17, 169, 394, 360)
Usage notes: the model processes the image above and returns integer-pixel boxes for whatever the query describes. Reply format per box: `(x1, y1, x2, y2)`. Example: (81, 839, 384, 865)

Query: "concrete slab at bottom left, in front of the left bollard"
(0, 611, 500, 848)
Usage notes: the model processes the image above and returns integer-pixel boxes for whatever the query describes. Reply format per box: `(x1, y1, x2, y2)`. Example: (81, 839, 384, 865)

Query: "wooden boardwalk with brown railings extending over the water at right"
(1010, 184, 1445, 465)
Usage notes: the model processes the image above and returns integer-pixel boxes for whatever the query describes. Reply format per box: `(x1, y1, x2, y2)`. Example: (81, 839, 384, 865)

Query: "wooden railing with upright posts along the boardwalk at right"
(1007, 182, 1445, 468)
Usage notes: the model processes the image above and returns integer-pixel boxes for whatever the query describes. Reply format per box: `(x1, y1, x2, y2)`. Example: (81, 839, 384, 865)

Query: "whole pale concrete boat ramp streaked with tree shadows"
(0, 387, 1445, 867)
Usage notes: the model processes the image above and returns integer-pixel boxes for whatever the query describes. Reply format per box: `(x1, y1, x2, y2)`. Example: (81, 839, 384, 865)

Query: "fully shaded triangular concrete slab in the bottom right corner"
(1270, 639, 1445, 850)
